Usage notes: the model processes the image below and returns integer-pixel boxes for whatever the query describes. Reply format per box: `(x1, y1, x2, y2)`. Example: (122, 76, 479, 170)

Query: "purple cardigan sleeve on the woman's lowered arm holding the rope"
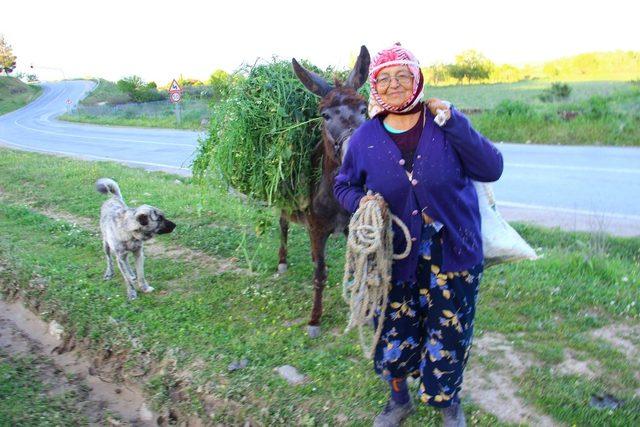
(333, 137, 366, 213)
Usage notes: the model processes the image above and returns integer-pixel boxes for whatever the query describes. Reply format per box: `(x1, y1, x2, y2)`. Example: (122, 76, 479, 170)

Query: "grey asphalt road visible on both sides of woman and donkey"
(0, 81, 640, 236)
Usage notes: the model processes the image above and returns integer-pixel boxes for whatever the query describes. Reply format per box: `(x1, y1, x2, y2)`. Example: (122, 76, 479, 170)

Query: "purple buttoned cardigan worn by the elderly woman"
(334, 107, 503, 281)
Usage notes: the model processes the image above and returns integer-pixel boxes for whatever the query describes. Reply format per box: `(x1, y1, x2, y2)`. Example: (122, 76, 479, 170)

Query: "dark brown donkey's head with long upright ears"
(292, 46, 371, 163)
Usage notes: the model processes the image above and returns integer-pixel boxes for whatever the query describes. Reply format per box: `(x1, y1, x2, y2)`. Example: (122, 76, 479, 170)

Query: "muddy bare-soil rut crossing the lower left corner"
(0, 300, 156, 426)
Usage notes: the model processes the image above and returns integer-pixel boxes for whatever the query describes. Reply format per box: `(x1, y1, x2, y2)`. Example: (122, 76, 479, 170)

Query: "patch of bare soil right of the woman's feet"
(463, 332, 558, 426)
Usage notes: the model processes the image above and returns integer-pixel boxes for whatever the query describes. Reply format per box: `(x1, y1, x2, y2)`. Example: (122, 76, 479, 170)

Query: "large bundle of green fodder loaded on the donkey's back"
(193, 59, 328, 210)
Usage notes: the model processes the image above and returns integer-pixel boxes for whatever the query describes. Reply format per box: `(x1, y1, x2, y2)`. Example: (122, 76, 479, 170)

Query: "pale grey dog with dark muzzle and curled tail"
(96, 178, 176, 300)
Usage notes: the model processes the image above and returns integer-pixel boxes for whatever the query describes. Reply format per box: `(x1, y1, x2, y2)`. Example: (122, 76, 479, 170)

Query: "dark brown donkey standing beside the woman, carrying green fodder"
(278, 46, 371, 338)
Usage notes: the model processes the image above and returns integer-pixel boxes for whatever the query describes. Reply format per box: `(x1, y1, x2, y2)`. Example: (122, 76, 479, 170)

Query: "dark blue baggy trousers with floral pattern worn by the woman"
(374, 224, 483, 407)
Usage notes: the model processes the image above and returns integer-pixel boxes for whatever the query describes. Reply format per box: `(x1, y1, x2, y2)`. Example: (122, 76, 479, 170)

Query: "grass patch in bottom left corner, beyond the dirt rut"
(0, 352, 88, 426)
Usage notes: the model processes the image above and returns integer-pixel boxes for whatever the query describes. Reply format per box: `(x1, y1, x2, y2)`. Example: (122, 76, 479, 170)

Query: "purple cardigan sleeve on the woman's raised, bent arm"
(442, 106, 504, 182)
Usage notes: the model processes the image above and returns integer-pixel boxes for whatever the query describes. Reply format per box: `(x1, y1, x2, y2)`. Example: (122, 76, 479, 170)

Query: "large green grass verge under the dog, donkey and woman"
(0, 149, 640, 426)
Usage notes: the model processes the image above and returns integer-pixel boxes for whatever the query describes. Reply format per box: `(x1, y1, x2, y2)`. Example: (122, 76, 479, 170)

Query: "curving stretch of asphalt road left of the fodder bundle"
(0, 81, 199, 175)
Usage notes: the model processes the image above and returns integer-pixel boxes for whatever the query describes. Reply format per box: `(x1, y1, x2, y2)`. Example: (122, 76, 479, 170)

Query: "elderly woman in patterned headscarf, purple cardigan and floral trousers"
(334, 44, 503, 426)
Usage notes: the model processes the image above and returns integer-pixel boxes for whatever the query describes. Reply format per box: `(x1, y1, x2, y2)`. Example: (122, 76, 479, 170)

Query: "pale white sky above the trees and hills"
(0, 0, 640, 84)
